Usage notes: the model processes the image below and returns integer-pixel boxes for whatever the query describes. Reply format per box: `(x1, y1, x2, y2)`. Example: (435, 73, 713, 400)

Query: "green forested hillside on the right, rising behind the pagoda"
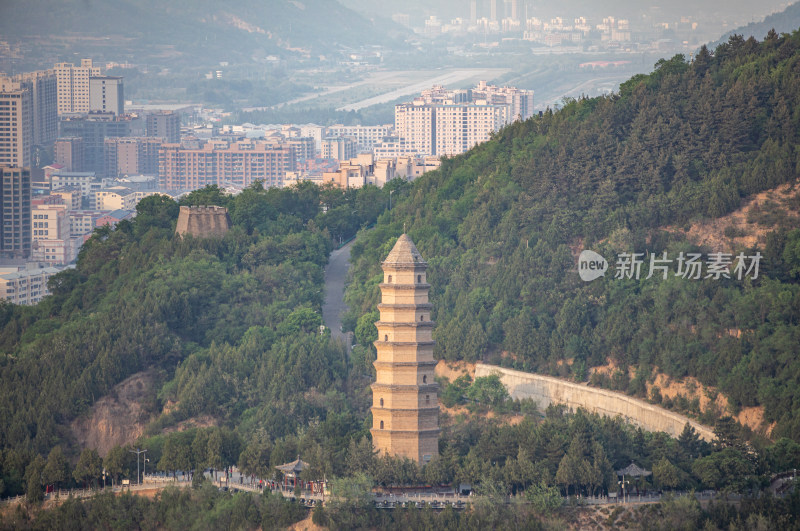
(348, 32, 800, 440)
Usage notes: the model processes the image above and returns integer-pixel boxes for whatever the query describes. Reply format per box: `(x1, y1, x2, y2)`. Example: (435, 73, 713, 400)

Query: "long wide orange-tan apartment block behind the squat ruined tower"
(158, 140, 296, 190)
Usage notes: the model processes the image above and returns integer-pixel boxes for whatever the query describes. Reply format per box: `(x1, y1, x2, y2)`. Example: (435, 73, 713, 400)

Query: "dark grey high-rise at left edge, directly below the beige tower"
(0, 166, 31, 259)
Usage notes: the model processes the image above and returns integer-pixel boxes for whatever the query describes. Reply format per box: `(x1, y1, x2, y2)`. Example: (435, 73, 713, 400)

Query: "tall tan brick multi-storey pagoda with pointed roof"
(371, 234, 439, 463)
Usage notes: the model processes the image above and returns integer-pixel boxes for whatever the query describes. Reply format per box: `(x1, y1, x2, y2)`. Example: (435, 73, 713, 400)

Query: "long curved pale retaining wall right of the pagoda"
(475, 363, 714, 442)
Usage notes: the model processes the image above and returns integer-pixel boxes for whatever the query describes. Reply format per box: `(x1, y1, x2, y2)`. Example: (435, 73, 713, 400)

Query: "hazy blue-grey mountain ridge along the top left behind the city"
(0, 0, 400, 66)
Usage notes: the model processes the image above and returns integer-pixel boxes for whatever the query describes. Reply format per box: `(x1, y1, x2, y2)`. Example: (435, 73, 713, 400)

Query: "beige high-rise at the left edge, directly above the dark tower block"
(0, 78, 33, 167)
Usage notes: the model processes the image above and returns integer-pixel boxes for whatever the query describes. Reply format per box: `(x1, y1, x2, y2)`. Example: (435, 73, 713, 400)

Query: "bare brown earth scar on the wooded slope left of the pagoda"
(70, 370, 157, 457)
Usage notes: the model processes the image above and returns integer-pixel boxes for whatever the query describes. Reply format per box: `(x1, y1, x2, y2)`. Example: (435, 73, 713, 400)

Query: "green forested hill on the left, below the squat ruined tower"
(0, 183, 403, 496)
